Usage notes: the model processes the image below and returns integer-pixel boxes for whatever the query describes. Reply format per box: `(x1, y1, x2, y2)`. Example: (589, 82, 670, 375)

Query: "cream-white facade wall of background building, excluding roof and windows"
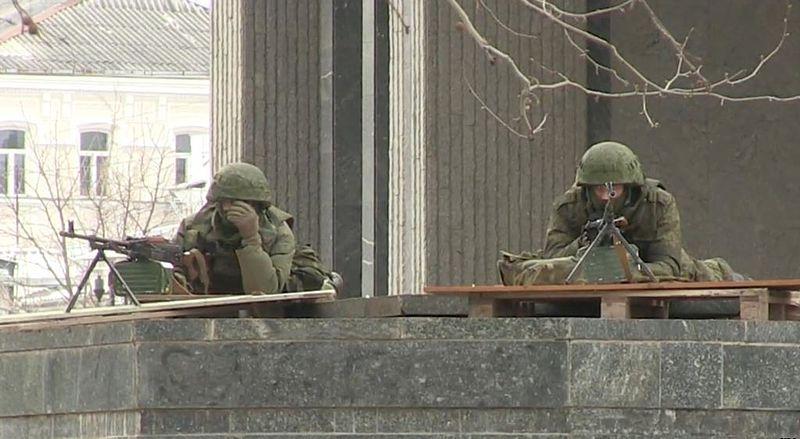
(0, 75, 211, 310)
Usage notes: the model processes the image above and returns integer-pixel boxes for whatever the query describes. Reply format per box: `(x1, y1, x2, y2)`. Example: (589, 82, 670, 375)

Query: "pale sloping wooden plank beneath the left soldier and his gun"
(0, 290, 336, 326)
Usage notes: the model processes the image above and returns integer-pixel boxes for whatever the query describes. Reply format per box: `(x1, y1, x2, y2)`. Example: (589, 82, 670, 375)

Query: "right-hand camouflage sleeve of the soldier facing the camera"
(642, 192, 683, 277)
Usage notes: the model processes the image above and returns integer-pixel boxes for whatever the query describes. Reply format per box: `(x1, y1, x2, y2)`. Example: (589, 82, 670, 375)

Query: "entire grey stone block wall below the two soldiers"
(0, 318, 800, 438)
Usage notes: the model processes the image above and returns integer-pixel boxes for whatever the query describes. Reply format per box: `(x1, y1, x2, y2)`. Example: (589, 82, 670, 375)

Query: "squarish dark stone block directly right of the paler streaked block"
(661, 342, 722, 408)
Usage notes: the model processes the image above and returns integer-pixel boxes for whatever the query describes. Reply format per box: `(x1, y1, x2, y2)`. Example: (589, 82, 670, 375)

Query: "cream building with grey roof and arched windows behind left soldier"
(0, 0, 210, 307)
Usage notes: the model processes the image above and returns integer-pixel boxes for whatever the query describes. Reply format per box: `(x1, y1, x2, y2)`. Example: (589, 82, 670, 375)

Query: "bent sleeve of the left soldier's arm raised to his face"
(236, 223, 294, 294)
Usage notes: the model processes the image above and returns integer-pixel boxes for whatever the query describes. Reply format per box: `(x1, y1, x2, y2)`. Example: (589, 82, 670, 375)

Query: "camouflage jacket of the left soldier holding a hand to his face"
(174, 203, 295, 294)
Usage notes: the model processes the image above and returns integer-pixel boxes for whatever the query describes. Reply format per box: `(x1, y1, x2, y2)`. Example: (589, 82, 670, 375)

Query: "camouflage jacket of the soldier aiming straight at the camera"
(543, 179, 704, 279)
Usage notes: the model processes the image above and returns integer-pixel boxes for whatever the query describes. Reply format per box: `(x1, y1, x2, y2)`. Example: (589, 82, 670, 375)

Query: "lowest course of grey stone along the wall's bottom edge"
(0, 408, 800, 439)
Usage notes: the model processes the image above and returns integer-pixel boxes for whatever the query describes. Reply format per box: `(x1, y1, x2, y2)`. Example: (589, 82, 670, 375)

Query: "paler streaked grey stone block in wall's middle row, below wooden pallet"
(569, 342, 660, 408)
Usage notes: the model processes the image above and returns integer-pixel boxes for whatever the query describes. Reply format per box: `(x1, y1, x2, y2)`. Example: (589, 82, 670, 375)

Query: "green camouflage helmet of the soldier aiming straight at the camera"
(575, 142, 644, 186)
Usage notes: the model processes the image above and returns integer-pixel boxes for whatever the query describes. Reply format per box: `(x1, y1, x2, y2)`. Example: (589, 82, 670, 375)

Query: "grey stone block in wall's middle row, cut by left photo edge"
(0, 352, 44, 416)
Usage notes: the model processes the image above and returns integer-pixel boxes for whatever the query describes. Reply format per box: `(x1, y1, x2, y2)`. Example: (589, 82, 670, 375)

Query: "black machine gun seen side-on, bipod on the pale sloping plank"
(59, 221, 207, 312)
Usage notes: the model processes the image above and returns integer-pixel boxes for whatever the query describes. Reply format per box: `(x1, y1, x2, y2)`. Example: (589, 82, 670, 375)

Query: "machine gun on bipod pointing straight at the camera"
(566, 182, 658, 284)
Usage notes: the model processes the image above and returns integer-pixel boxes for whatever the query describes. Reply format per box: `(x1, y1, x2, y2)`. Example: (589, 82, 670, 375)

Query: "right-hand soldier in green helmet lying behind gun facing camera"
(542, 142, 741, 281)
